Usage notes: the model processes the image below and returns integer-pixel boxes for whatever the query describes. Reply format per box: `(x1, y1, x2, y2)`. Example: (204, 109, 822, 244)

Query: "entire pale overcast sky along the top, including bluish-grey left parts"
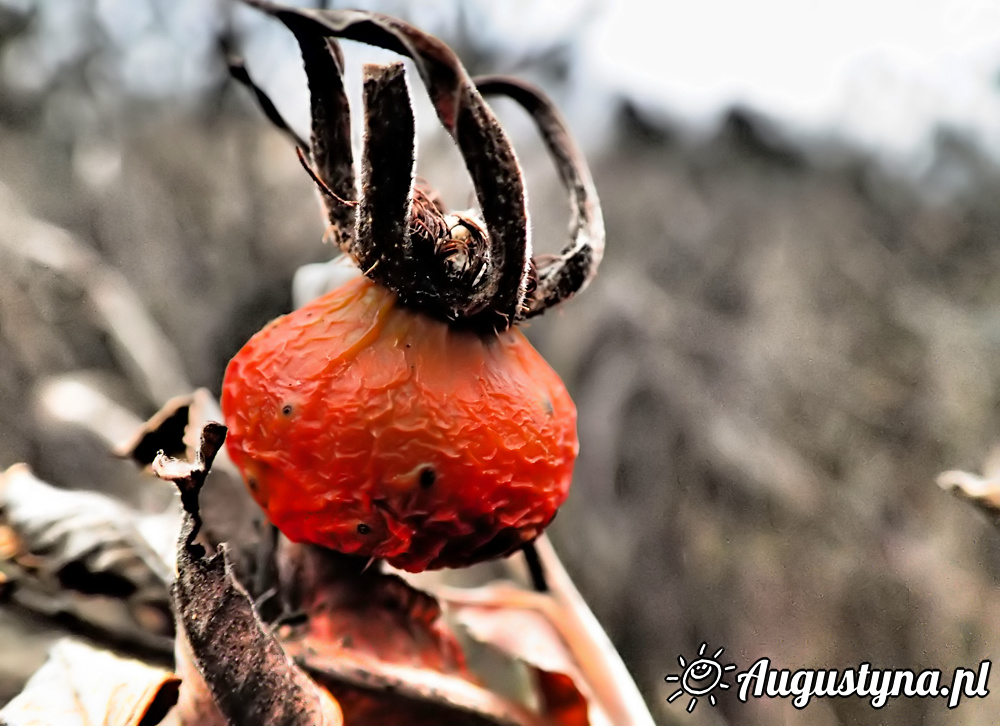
(7, 0, 1000, 170)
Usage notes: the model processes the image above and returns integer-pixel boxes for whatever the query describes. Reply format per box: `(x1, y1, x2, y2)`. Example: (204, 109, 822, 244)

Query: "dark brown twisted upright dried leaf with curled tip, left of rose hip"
(159, 423, 343, 726)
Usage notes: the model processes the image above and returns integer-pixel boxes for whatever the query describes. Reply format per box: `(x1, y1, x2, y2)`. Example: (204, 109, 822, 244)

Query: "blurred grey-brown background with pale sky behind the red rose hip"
(0, 0, 1000, 726)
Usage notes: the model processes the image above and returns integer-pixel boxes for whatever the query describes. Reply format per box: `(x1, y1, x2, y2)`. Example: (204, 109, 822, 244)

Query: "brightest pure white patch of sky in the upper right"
(587, 0, 1000, 162)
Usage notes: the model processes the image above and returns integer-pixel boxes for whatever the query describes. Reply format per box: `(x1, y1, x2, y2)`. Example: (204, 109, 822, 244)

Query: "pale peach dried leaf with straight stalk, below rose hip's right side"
(437, 535, 653, 726)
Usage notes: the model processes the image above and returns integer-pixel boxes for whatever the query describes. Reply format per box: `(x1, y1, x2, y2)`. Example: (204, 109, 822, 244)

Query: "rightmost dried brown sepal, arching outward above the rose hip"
(473, 76, 604, 317)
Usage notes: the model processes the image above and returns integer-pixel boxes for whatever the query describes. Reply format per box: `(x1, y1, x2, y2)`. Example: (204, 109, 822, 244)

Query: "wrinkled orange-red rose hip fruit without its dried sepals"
(222, 277, 578, 572)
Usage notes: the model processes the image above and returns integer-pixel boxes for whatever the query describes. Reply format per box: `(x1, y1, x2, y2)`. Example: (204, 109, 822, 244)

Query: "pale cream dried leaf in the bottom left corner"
(0, 639, 180, 726)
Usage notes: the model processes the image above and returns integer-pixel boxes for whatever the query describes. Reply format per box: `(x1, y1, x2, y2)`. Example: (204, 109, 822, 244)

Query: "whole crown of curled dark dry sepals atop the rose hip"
(231, 0, 604, 331)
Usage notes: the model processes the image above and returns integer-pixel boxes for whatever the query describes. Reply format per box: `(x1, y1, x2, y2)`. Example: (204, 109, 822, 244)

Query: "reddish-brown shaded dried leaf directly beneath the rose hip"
(279, 540, 543, 726)
